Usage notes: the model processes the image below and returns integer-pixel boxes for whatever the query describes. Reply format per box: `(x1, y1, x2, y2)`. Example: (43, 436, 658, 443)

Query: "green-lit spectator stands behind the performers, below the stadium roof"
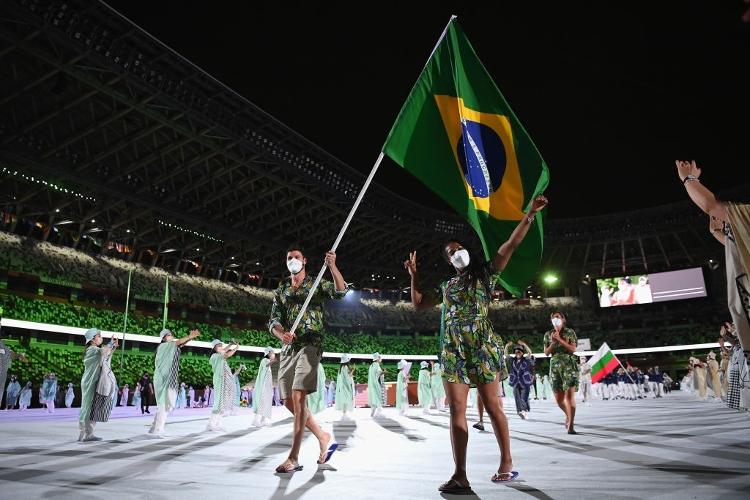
(0, 232, 724, 354)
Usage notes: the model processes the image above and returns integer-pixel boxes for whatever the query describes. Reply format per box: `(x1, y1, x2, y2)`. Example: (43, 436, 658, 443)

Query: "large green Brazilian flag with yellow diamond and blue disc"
(383, 19, 549, 296)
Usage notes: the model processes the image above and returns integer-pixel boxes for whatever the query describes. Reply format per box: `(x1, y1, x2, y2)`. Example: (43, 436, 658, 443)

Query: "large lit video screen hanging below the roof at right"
(596, 267, 706, 307)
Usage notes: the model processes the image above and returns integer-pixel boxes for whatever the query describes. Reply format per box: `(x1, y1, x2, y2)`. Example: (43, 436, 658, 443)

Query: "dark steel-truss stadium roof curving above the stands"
(0, 0, 740, 289)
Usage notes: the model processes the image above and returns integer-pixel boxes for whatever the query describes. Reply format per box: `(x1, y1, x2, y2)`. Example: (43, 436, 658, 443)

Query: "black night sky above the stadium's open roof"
(109, 0, 750, 217)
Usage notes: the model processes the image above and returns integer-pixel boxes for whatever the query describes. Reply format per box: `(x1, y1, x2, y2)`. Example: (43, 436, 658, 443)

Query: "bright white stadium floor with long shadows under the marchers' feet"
(0, 392, 750, 500)
